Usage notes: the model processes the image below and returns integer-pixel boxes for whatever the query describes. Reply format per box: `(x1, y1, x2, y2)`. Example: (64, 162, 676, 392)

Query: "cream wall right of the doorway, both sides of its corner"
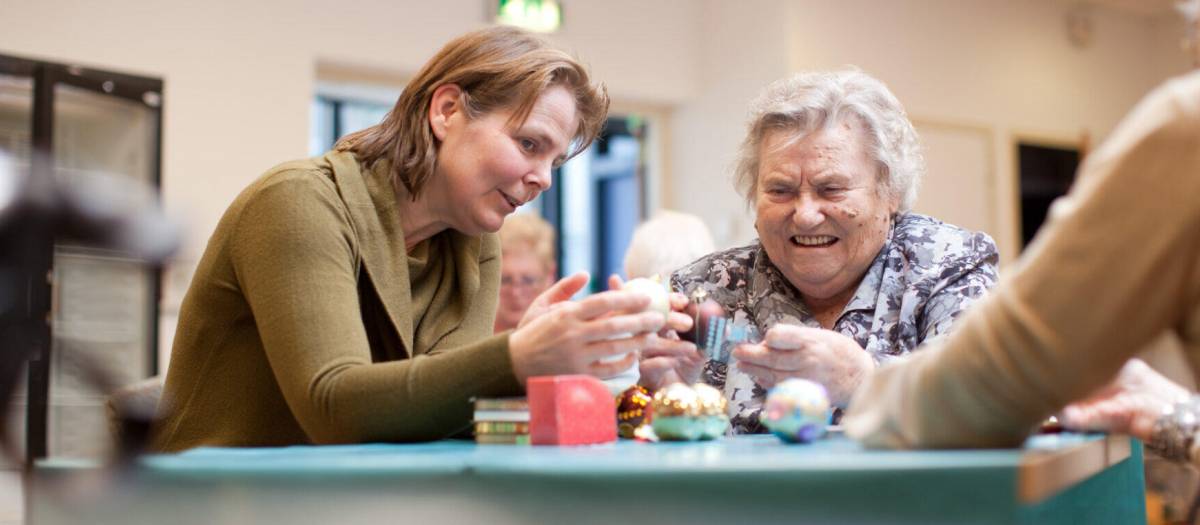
(670, 0, 1186, 260)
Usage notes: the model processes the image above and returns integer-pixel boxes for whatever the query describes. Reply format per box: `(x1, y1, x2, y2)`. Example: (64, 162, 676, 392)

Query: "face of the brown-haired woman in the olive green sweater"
(430, 86, 577, 235)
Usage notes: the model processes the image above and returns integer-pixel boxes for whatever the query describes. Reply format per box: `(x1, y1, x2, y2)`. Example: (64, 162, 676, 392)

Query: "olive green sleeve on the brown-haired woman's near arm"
(233, 172, 521, 443)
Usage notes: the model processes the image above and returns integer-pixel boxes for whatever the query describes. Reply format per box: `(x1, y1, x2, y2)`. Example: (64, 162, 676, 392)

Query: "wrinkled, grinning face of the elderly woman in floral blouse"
(755, 119, 895, 300)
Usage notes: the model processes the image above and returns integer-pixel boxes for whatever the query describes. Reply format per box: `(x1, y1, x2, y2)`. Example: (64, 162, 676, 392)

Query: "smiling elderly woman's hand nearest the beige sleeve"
(733, 325, 875, 406)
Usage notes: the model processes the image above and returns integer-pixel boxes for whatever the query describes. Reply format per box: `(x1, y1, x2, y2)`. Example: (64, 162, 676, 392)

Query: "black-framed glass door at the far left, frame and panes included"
(0, 55, 162, 464)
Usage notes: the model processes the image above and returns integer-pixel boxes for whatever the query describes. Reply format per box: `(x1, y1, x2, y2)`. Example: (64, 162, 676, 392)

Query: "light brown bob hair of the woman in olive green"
(335, 26, 608, 200)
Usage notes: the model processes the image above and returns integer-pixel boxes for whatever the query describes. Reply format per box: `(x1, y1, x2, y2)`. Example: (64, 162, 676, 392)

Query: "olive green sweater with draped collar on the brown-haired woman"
(154, 152, 521, 452)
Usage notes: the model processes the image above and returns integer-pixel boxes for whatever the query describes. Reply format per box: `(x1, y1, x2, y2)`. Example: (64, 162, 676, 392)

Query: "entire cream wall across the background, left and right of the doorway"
(0, 0, 1187, 366)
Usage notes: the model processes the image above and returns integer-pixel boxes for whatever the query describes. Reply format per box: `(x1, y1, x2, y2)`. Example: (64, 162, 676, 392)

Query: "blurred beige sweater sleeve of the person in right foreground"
(845, 73, 1200, 448)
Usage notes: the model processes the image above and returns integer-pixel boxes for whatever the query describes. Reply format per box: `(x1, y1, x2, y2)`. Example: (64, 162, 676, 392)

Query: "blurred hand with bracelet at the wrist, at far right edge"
(1060, 360, 1188, 441)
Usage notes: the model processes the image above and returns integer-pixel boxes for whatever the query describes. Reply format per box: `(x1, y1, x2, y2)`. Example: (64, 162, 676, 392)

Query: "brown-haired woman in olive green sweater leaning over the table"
(154, 28, 695, 451)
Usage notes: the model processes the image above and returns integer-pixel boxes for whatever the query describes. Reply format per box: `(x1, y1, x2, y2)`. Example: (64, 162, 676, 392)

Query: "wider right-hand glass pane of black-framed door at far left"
(47, 67, 162, 458)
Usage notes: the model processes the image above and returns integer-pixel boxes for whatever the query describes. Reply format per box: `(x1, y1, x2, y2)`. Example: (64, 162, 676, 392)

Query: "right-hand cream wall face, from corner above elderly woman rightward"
(792, 0, 1180, 260)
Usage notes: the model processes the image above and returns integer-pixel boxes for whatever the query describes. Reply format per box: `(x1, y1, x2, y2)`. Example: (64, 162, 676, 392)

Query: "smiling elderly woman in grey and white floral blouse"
(672, 70, 997, 433)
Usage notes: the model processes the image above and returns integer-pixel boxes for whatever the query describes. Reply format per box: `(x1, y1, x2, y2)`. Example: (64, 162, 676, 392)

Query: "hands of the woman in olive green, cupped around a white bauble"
(509, 273, 695, 384)
